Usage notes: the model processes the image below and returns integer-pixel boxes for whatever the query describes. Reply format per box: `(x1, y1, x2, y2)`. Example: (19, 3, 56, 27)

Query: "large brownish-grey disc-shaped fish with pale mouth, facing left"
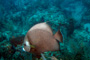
(23, 22, 63, 56)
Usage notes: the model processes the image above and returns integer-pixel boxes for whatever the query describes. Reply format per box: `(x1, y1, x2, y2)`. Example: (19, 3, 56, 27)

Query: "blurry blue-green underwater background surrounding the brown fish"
(0, 0, 90, 60)
